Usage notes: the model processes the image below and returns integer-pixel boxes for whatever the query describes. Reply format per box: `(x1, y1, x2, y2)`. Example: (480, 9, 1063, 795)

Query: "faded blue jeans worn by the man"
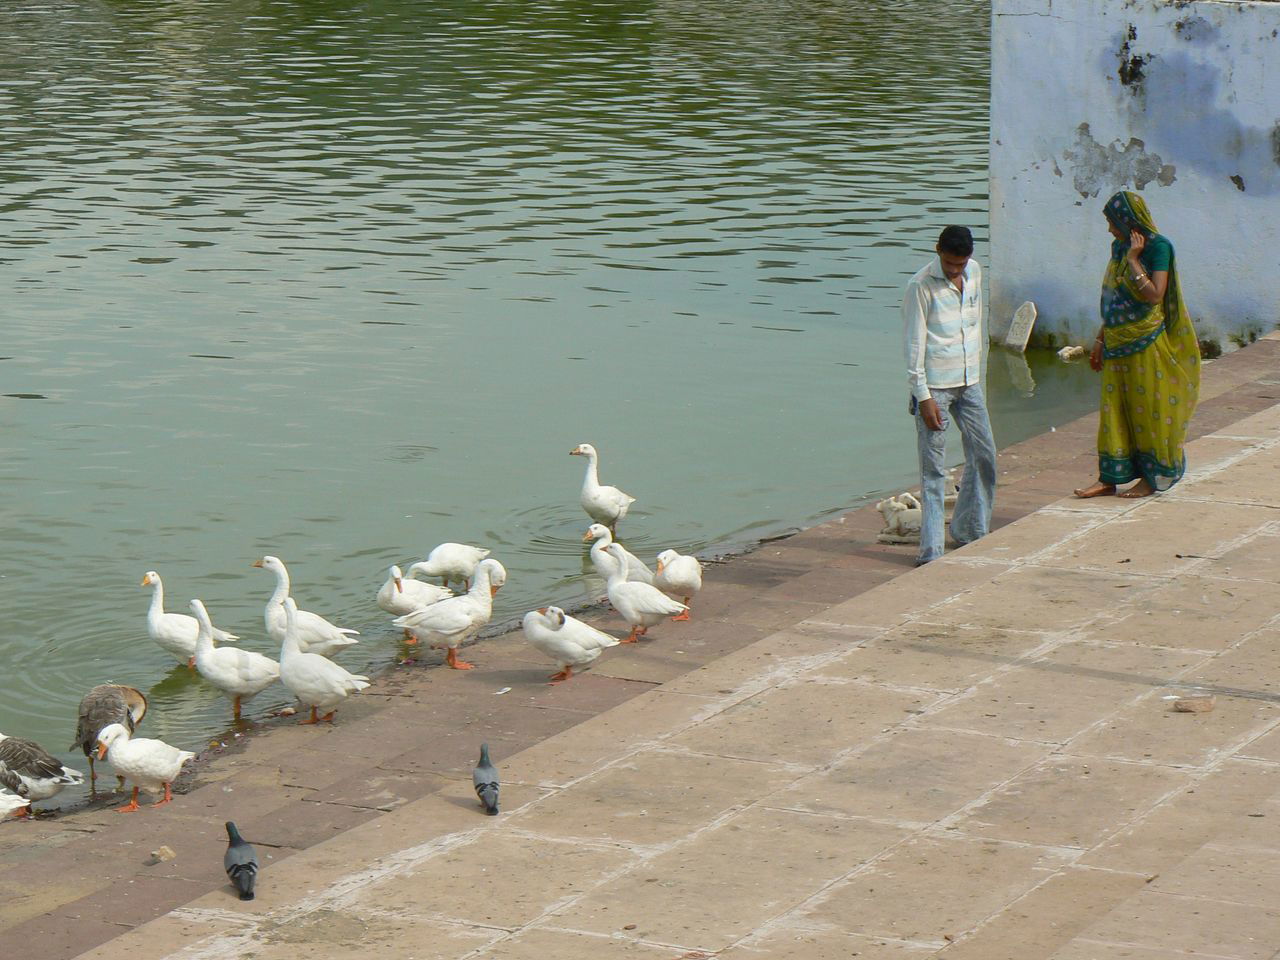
(915, 384, 996, 566)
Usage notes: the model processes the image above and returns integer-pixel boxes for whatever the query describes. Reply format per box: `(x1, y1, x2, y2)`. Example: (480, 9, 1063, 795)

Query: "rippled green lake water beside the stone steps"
(0, 0, 1096, 796)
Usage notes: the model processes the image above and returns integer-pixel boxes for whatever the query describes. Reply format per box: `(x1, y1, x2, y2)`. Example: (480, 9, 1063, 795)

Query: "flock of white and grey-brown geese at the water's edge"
(0, 443, 703, 819)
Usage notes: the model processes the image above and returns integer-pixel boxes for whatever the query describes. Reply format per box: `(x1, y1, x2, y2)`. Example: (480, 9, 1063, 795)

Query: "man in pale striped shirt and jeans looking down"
(902, 227, 996, 566)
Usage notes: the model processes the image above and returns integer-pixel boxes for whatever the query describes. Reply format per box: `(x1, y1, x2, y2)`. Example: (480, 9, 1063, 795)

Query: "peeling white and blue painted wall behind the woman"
(988, 0, 1280, 346)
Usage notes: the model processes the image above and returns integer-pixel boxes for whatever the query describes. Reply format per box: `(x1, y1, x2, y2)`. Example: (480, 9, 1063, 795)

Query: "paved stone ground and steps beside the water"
(0, 338, 1280, 960)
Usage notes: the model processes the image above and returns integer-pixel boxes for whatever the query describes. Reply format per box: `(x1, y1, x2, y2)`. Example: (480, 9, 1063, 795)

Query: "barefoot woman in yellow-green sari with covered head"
(1075, 191, 1199, 498)
